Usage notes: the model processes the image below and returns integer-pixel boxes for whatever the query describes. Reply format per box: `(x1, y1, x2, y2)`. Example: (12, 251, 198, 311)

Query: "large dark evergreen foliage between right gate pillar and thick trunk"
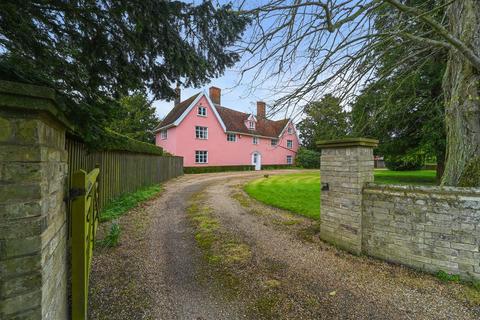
(352, 0, 446, 178)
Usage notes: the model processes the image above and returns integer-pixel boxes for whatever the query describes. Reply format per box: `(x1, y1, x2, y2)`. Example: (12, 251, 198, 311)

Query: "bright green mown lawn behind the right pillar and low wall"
(245, 170, 435, 219)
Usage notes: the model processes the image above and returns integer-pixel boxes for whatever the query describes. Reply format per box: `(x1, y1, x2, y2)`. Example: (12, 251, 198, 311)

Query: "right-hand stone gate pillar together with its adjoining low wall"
(318, 138, 480, 279)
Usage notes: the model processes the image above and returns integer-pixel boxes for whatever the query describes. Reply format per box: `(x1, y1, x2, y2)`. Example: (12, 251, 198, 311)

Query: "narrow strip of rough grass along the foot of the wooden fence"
(100, 185, 162, 222)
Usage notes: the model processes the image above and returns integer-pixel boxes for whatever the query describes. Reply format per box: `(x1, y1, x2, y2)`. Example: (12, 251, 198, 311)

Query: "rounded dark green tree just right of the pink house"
(297, 94, 349, 149)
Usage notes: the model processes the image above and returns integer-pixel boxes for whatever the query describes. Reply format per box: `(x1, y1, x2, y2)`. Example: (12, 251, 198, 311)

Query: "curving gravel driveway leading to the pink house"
(90, 170, 480, 320)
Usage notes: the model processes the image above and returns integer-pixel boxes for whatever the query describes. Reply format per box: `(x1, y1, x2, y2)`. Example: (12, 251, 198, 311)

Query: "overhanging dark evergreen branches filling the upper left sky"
(0, 0, 248, 142)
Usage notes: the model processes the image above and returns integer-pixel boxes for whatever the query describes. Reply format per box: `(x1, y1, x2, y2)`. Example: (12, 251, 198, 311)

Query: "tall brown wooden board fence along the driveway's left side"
(66, 139, 183, 210)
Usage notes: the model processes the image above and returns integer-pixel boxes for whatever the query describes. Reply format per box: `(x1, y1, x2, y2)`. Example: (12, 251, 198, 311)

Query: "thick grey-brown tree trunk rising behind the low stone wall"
(442, 0, 480, 186)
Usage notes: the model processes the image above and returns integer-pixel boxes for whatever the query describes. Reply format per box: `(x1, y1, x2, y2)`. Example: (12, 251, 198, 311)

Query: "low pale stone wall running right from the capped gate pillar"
(362, 184, 480, 279)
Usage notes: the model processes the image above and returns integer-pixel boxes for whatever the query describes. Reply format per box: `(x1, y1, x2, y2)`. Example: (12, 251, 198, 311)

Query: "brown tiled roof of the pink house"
(158, 94, 289, 137)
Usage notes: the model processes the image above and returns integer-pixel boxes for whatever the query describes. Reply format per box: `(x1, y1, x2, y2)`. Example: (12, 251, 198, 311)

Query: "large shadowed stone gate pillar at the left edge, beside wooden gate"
(0, 82, 68, 320)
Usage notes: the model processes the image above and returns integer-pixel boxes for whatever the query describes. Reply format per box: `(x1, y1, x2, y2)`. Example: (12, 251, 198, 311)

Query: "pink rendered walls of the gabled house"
(156, 97, 299, 167)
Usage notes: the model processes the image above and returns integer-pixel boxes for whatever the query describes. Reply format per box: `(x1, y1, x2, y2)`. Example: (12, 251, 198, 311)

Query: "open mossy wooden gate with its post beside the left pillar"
(70, 168, 100, 320)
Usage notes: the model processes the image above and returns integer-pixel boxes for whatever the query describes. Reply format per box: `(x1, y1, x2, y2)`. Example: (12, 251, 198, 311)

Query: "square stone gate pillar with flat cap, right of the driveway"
(317, 138, 378, 254)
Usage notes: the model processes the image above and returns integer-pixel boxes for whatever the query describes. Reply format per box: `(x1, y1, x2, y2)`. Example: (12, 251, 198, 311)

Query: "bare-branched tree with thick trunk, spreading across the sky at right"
(242, 0, 480, 185)
